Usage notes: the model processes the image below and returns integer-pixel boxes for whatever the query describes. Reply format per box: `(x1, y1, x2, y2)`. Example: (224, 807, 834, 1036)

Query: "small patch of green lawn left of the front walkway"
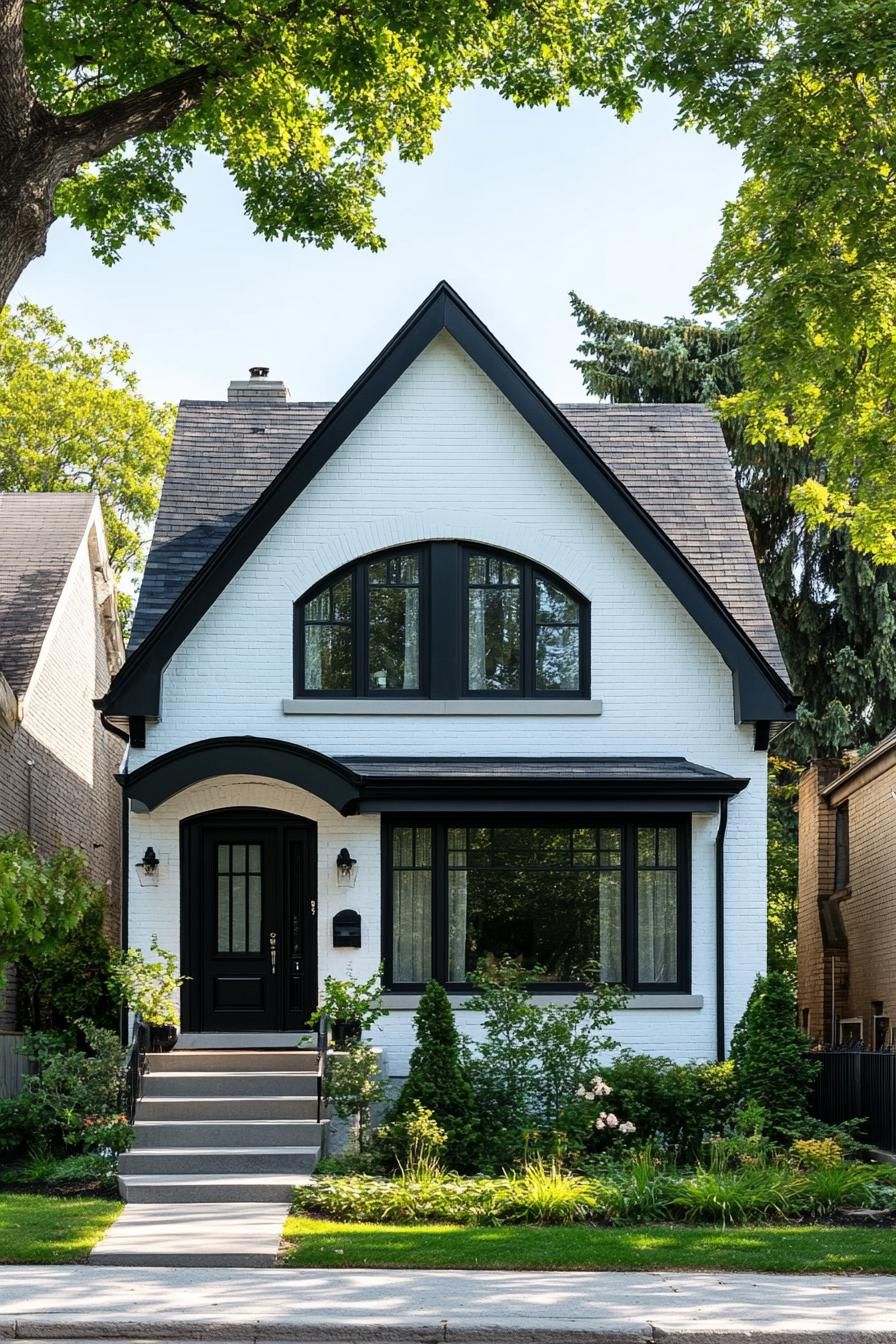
(0, 1193, 121, 1265)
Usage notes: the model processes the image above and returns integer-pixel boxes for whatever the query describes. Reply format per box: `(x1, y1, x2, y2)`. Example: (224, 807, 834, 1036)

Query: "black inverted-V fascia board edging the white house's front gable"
(102, 281, 797, 722)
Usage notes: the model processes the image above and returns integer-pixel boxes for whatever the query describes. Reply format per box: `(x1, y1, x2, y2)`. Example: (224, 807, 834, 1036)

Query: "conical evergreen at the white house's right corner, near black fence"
(731, 972, 818, 1142)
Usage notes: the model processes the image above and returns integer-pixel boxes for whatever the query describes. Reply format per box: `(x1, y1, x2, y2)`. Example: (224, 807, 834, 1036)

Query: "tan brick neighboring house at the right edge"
(797, 732, 896, 1050)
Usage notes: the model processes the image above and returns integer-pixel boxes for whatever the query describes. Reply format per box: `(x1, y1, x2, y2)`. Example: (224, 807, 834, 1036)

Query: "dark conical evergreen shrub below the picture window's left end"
(390, 980, 478, 1171)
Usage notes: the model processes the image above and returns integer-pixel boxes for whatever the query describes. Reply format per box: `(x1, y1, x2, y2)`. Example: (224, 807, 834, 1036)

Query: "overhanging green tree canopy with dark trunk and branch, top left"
(0, 0, 637, 302)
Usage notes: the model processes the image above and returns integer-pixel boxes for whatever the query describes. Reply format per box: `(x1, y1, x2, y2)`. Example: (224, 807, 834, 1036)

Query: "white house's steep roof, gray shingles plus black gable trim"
(103, 282, 794, 720)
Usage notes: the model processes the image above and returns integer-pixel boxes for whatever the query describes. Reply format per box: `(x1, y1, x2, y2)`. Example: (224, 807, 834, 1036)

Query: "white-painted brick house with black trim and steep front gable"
(103, 285, 794, 1075)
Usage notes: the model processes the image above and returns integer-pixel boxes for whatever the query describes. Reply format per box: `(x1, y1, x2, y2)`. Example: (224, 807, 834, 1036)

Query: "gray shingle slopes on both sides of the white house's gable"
(129, 402, 787, 679)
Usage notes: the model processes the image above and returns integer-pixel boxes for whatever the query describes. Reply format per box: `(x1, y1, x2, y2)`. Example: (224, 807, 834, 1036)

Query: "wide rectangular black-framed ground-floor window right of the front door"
(384, 818, 689, 991)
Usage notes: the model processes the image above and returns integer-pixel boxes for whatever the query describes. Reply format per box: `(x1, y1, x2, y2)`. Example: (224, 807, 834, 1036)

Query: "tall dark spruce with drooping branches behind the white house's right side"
(571, 294, 896, 763)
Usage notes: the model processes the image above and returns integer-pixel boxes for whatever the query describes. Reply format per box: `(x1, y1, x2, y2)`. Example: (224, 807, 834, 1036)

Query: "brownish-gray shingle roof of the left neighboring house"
(0, 491, 97, 695)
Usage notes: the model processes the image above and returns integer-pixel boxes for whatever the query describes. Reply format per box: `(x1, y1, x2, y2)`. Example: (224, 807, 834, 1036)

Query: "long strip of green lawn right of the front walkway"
(282, 1218, 896, 1274)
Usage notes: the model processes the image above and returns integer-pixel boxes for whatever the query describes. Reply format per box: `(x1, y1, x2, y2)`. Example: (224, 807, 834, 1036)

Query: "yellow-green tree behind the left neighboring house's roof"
(0, 304, 173, 618)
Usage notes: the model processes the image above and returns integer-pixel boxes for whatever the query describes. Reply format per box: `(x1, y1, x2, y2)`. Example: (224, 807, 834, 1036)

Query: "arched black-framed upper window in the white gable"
(296, 542, 588, 699)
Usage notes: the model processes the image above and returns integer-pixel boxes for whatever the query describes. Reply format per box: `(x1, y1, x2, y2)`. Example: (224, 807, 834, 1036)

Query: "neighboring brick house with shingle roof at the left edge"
(0, 492, 124, 1027)
